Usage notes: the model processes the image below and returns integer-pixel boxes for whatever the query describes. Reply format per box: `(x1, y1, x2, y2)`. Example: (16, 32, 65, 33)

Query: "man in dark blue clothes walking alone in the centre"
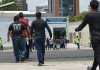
(31, 12, 52, 66)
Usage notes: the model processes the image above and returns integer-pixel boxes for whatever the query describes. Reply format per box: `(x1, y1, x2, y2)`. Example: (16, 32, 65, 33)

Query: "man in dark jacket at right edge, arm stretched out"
(75, 0, 100, 70)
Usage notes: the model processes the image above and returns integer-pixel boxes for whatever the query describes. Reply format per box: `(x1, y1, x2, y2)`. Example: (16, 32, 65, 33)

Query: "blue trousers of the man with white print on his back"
(12, 36, 26, 61)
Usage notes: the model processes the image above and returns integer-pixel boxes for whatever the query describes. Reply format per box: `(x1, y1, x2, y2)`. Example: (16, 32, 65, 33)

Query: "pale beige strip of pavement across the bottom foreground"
(0, 60, 92, 70)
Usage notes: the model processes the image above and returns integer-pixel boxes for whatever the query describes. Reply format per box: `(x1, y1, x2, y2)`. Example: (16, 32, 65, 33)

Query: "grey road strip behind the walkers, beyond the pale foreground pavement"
(0, 44, 93, 63)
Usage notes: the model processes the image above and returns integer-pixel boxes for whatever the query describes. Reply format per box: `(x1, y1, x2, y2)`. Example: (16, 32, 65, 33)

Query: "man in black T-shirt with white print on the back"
(7, 16, 26, 62)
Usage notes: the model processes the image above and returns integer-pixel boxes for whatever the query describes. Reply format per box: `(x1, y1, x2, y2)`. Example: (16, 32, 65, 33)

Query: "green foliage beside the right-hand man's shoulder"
(69, 12, 87, 22)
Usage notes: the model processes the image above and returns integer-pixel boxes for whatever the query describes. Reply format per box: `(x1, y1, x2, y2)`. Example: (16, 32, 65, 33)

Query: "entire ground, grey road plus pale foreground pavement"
(0, 44, 96, 70)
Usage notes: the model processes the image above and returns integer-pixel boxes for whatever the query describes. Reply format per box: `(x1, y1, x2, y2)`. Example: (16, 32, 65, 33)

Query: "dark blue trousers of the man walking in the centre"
(35, 38, 45, 63)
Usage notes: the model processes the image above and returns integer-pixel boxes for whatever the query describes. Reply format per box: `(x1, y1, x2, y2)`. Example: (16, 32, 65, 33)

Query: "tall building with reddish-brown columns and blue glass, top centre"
(48, 0, 80, 16)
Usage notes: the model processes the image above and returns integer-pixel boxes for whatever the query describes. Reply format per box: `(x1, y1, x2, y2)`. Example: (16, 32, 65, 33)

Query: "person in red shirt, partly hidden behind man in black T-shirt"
(18, 12, 31, 59)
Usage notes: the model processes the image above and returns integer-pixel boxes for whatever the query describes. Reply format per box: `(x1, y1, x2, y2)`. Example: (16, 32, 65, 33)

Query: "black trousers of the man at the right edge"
(92, 40, 100, 70)
